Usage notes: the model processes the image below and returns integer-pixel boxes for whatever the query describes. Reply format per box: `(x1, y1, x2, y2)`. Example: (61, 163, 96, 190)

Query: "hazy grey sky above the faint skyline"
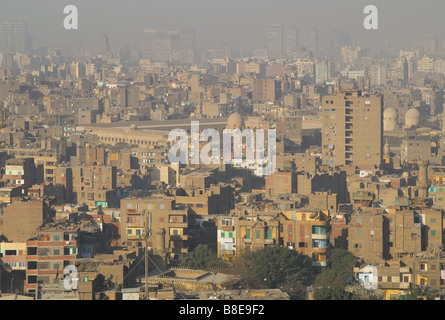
(0, 0, 445, 52)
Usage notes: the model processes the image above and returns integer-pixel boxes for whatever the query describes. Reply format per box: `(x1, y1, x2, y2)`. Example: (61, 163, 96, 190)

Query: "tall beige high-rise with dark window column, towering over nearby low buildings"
(322, 90, 383, 168)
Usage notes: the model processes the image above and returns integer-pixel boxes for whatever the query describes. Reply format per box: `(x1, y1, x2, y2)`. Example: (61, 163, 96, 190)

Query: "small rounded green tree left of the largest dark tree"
(180, 244, 225, 270)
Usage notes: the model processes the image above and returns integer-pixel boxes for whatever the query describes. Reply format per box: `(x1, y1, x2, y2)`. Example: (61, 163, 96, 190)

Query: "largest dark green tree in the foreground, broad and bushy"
(240, 246, 313, 299)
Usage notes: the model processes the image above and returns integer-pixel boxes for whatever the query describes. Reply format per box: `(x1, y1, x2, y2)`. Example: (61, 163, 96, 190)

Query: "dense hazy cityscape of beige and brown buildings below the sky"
(0, 5, 445, 300)
